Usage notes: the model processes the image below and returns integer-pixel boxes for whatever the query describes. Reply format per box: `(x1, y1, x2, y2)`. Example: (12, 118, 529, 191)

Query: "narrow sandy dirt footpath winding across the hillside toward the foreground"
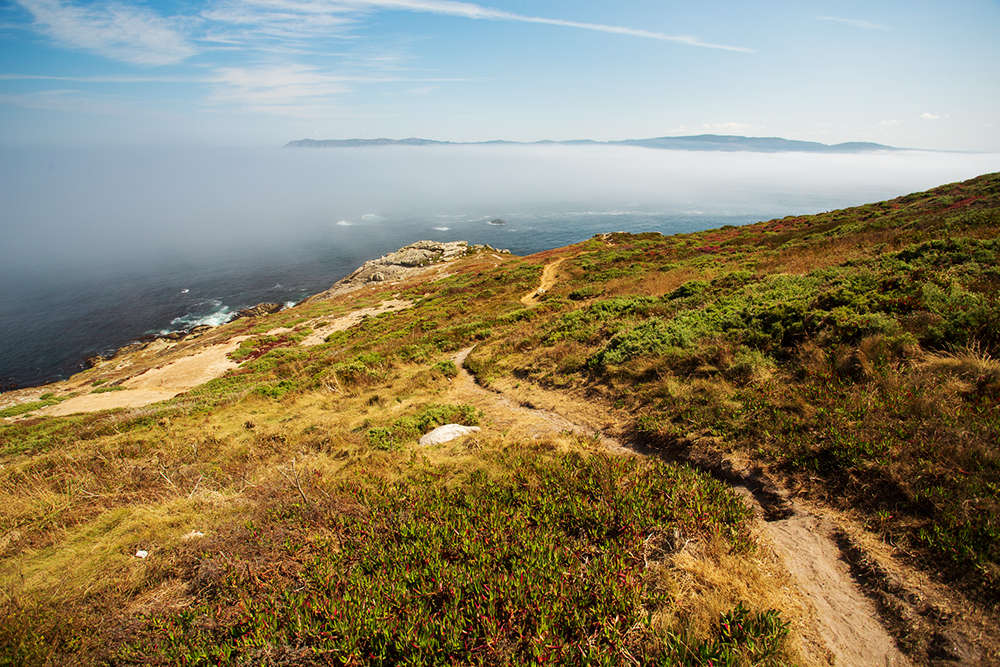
(452, 348, 911, 667)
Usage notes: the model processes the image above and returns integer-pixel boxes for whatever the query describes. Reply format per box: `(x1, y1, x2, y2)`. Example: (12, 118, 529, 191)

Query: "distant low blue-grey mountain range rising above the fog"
(285, 134, 900, 153)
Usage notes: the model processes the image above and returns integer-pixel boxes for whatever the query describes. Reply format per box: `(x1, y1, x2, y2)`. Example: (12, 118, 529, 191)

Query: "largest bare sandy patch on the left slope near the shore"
(36, 336, 248, 417)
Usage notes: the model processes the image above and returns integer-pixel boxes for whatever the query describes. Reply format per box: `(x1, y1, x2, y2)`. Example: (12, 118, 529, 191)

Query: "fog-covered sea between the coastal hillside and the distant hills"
(0, 145, 1000, 387)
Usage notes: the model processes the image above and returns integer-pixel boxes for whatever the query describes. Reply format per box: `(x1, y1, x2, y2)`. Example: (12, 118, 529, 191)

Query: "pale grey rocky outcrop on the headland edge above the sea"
(306, 241, 469, 303)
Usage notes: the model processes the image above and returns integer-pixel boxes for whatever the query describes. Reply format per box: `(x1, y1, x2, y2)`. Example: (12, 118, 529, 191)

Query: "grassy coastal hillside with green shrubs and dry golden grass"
(0, 174, 1000, 665)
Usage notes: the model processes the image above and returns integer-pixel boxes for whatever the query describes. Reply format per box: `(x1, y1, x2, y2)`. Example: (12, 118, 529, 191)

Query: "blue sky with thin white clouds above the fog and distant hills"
(0, 0, 1000, 151)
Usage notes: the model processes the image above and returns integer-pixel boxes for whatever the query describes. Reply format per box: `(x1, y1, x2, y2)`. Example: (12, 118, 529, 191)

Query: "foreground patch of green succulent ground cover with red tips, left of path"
(111, 448, 787, 665)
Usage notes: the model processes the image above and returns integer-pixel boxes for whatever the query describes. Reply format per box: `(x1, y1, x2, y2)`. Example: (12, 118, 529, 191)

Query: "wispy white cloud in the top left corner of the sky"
(18, 0, 195, 65)
